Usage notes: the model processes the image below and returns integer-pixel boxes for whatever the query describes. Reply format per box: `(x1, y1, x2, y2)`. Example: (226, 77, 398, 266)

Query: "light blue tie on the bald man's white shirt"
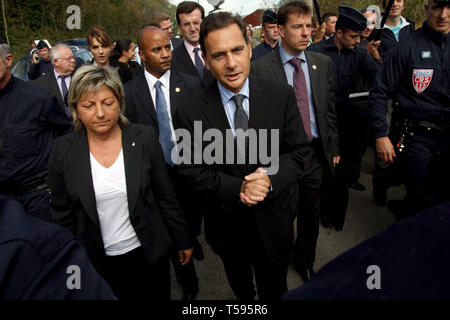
(155, 81, 175, 166)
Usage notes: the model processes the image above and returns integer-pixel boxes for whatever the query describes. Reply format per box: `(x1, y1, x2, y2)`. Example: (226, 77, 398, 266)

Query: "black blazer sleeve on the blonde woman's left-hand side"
(48, 139, 77, 236)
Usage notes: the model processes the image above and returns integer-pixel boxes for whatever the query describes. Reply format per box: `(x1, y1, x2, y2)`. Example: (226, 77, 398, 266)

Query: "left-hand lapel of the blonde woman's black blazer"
(70, 133, 100, 228)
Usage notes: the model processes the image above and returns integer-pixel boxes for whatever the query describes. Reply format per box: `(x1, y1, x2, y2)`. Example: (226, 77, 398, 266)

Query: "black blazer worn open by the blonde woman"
(49, 124, 192, 273)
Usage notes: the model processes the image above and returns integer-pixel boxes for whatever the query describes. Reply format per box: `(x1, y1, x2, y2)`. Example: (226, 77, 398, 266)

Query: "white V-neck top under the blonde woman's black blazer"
(90, 150, 141, 256)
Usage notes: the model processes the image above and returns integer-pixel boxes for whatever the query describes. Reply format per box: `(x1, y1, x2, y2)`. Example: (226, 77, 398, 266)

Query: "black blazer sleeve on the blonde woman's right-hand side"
(147, 129, 193, 250)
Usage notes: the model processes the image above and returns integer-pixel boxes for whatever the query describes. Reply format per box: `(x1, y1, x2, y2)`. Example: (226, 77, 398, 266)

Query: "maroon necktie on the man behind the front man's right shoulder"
(289, 58, 312, 141)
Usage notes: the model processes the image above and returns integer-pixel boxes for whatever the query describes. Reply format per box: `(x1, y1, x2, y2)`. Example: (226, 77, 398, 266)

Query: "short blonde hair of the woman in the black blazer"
(67, 65, 129, 131)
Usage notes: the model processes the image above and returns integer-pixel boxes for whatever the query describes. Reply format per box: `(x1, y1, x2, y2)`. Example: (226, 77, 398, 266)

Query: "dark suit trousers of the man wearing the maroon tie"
(293, 139, 328, 269)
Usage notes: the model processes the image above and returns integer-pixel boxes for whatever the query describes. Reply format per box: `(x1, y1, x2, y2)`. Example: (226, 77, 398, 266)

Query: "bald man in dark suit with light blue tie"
(125, 26, 202, 299)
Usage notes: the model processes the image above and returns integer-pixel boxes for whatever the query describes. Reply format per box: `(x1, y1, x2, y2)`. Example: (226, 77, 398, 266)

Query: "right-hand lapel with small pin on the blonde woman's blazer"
(121, 125, 143, 217)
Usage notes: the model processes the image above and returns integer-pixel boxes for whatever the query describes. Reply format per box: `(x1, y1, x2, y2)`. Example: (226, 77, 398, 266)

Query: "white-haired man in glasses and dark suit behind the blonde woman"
(34, 44, 75, 114)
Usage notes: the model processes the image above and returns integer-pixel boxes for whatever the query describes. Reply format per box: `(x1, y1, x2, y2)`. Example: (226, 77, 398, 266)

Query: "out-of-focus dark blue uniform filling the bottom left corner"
(0, 195, 114, 300)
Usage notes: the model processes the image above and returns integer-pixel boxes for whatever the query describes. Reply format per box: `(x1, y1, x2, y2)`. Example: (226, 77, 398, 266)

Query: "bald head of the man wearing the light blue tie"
(138, 26, 172, 79)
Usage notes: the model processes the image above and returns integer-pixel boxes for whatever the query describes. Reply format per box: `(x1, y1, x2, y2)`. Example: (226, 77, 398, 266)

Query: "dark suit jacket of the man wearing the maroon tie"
(251, 50, 339, 173)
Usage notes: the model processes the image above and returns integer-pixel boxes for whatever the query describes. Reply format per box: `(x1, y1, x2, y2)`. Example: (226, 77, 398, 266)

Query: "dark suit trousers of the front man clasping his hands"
(214, 210, 288, 300)
